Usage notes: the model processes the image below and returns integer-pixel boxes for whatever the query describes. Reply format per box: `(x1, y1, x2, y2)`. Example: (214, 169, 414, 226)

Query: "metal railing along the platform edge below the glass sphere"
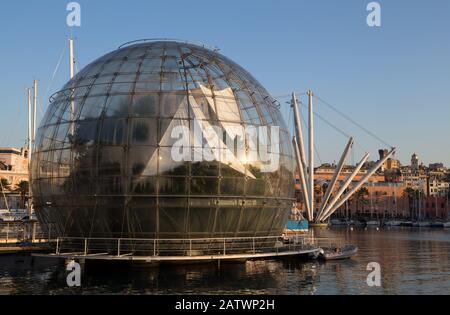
(55, 236, 317, 257)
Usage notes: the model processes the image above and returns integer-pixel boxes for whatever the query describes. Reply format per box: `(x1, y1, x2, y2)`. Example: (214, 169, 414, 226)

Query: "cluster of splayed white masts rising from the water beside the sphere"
(291, 91, 396, 224)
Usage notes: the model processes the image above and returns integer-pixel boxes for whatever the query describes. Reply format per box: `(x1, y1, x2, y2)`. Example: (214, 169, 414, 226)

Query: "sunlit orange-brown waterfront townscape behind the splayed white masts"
(296, 150, 450, 219)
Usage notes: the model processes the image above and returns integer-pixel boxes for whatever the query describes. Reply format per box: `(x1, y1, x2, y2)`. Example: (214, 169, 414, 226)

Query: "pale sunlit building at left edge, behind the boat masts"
(0, 148, 29, 190)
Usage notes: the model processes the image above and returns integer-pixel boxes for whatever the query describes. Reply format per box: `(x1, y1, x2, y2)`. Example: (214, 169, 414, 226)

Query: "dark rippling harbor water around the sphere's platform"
(0, 228, 450, 295)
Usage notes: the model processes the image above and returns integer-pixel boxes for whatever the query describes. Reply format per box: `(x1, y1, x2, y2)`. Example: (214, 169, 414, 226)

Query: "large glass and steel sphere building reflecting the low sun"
(32, 41, 294, 238)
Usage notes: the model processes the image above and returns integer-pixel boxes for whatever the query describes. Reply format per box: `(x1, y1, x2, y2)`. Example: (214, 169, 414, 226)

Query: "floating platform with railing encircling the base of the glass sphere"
(33, 236, 320, 264)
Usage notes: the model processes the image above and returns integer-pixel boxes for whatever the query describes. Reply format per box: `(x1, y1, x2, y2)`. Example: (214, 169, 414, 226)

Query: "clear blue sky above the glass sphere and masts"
(0, 0, 450, 166)
